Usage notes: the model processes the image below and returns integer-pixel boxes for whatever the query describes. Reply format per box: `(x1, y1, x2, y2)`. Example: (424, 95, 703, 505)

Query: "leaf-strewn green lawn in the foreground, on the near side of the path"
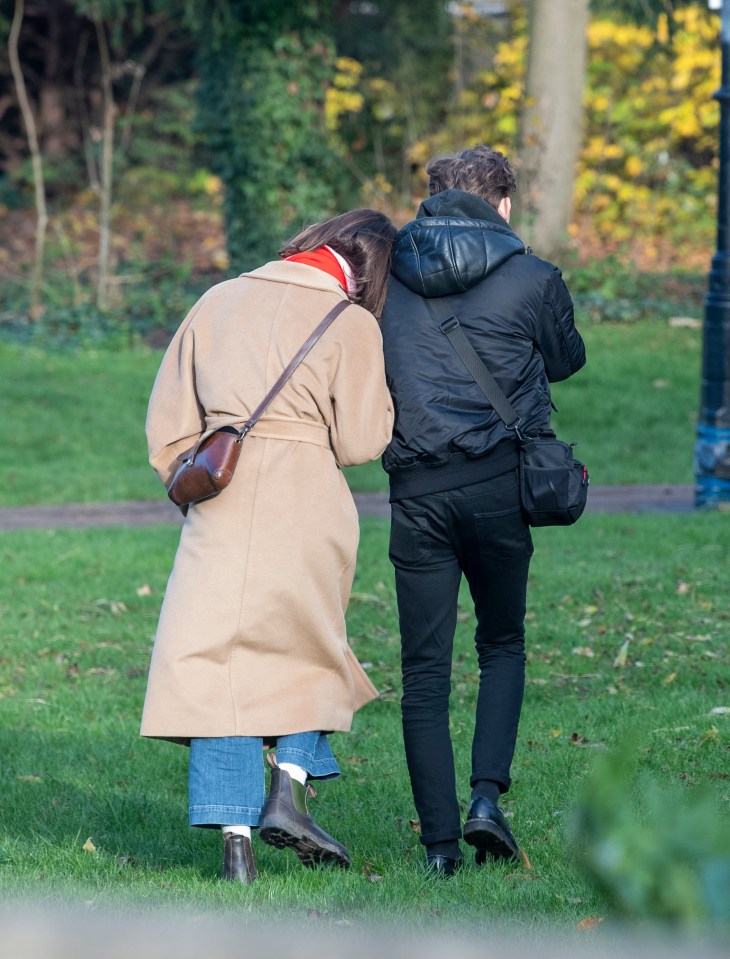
(0, 515, 730, 936)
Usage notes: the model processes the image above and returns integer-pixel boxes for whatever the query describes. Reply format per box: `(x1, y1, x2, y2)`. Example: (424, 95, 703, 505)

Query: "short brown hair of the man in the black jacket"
(426, 143, 517, 209)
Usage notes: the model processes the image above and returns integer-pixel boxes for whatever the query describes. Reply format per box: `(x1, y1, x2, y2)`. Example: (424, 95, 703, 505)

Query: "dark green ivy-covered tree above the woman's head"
(199, 3, 350, 270)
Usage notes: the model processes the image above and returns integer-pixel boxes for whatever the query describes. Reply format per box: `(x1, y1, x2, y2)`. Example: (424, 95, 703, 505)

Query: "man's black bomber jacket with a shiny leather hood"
(382, 190, 585, 500)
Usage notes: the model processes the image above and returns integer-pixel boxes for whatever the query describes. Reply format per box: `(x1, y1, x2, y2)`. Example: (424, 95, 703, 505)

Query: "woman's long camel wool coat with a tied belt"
(141, 261, 393, 743)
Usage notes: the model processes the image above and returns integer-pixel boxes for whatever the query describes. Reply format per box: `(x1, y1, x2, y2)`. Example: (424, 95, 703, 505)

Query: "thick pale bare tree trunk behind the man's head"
(515, 0, 588, 256)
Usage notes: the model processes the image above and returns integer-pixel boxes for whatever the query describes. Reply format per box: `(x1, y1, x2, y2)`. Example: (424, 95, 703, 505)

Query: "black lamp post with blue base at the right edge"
(694, 0, 730, 509)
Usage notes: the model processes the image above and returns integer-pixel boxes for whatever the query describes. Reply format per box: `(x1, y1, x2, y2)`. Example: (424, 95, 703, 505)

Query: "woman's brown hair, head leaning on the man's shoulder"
(279, 210, 396, 319)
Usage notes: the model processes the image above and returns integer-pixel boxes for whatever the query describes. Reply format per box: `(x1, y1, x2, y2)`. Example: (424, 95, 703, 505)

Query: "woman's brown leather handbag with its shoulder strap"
(167, 300, 350, 516)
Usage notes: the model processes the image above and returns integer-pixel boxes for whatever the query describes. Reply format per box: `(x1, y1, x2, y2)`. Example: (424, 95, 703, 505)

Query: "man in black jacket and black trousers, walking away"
(382, 146, 585, 876)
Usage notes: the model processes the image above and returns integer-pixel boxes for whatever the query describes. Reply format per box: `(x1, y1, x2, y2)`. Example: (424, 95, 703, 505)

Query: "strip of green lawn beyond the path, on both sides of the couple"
(0, 321, 701, 506)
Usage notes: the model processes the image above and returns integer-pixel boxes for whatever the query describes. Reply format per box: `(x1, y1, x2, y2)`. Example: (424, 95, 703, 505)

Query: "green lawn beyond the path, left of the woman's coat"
(0, 344, 161, 506)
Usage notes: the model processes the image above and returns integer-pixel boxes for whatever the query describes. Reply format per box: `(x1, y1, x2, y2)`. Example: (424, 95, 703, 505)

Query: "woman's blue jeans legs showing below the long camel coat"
(188, 732, 340, 826)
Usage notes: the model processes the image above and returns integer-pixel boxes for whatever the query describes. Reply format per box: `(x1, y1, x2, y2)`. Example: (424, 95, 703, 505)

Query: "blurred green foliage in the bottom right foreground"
(571, 744, 730, 932)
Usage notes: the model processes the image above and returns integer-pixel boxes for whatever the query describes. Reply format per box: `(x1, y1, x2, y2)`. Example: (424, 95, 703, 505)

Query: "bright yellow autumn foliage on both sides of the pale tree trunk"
(409, 5, 720, 249)
